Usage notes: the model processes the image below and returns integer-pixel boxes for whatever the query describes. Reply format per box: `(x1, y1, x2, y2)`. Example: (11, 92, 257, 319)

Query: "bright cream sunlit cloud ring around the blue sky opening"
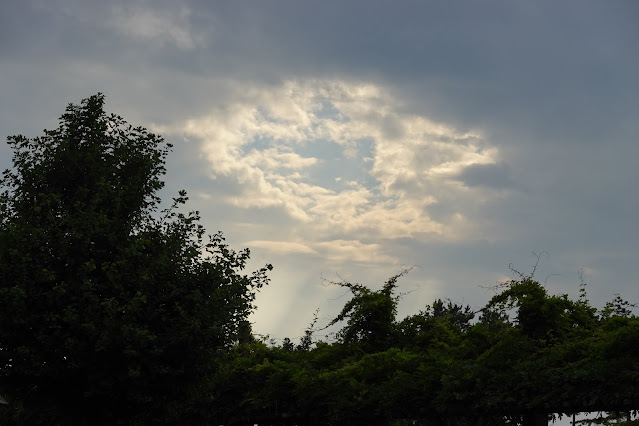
(161, 80, 500, 253)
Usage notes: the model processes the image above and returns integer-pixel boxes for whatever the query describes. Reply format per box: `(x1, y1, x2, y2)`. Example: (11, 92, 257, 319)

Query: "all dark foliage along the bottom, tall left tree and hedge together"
(0, 94, 639, 426)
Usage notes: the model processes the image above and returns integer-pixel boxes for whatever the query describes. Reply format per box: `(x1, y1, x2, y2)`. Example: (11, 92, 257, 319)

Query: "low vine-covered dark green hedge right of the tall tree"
(216, 276, 639, 425)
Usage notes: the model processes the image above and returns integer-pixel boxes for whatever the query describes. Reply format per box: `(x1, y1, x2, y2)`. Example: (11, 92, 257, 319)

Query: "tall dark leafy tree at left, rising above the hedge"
(0, 94, 271, 424)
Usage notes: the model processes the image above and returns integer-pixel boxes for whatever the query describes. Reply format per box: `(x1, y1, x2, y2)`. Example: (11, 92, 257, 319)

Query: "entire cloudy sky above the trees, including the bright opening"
(0, 0, 639, 339)
